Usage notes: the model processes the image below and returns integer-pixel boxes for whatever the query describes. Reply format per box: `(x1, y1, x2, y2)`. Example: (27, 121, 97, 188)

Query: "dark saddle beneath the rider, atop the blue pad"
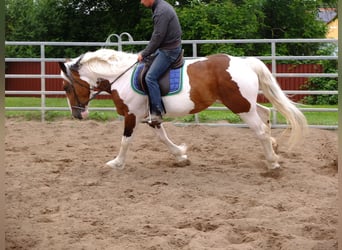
(138, 50, 184, 96)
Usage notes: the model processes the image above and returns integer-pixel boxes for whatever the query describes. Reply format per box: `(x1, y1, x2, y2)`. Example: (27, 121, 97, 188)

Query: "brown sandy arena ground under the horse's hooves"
(5, 119, 338, 250)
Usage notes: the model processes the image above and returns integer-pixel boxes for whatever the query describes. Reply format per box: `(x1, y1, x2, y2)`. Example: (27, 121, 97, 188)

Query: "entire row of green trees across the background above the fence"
(5, 0, 337, 57)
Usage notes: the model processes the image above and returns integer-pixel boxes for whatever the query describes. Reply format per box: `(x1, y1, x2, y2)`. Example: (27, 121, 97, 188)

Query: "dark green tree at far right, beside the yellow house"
(261, 0, 327, 55)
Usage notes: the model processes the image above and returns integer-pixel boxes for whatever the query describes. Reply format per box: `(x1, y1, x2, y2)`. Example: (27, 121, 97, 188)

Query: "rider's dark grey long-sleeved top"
(141, 0, 182, 57)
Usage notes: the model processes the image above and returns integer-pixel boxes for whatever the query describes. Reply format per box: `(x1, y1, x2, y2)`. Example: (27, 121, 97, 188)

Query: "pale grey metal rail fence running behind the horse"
(5, 37, 338, 129)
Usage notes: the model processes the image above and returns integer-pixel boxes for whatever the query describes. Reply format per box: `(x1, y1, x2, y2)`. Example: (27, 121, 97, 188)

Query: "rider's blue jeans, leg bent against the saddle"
(145, 46, 182, 115)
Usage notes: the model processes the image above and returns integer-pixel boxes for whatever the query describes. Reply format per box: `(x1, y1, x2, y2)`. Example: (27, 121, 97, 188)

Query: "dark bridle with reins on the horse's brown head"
(65, 61, 138, 111)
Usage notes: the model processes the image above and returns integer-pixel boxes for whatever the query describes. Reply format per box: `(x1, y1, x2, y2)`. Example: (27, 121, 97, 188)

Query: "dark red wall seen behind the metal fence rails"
(5, 62, 323, 103)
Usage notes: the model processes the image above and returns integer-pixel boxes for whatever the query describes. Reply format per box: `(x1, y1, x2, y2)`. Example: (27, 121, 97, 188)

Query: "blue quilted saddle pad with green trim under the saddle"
(131, 63, 183, 95)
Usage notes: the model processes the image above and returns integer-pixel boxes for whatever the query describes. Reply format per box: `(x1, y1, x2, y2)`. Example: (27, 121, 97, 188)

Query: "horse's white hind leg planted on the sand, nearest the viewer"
(239, 108, 280, 169)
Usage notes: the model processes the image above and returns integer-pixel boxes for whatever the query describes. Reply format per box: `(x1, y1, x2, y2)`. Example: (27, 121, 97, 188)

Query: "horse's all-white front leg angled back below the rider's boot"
(153, 124, 189, 165)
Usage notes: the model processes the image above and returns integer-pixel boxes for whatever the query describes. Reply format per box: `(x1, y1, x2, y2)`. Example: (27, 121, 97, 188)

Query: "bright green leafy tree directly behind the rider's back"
(178, 0, 264, 55)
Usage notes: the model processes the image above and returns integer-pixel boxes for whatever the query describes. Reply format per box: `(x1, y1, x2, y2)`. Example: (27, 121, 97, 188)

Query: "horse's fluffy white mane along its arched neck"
(81, 49, 137, 76)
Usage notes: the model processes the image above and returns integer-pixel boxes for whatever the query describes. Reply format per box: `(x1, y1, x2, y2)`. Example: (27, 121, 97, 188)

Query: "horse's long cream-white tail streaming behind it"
(247, 57, 307, 146)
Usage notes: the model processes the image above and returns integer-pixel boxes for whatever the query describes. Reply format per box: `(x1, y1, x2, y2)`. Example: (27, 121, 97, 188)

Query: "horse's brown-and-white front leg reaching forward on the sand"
(106, 115, 136, 169)
